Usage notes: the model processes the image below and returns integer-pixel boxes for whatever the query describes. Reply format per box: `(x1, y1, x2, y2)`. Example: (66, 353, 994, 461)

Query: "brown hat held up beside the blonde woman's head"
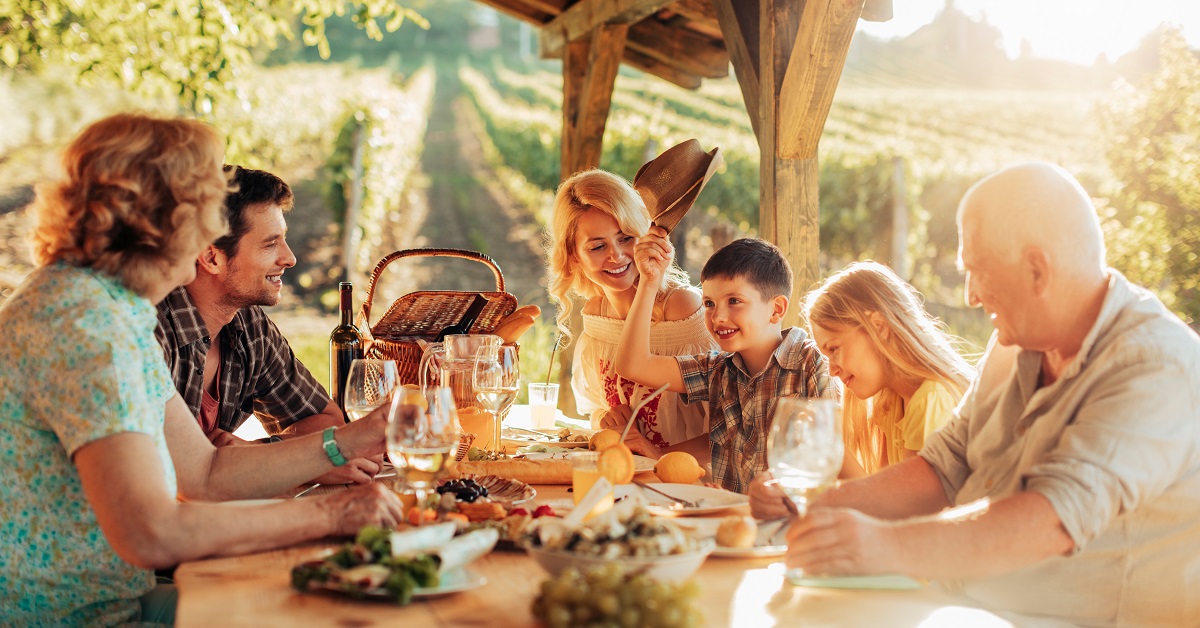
(634, 139, 721, 232)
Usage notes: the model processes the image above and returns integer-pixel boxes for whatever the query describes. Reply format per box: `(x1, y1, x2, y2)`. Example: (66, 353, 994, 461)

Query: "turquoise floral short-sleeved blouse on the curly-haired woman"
(0, 263, 175, 626)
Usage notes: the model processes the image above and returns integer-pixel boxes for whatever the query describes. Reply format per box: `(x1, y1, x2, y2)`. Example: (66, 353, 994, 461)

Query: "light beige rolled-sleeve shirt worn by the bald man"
(920, 270, 1200, 626)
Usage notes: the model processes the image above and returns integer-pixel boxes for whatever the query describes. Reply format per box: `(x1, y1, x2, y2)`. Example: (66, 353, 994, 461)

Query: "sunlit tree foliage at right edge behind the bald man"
(1099, 30, 1200, 324)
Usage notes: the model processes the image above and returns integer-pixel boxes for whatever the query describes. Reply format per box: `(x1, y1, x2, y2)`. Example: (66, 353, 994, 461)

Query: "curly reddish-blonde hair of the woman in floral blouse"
(31, 113, 229, 294)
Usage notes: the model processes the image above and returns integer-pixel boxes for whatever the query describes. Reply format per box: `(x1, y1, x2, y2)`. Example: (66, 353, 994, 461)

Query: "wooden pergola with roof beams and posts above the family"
(468, 0, 892, 323)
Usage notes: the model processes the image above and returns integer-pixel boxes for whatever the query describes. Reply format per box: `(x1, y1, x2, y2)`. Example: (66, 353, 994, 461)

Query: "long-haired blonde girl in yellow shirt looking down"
(805, 262, 974, 477)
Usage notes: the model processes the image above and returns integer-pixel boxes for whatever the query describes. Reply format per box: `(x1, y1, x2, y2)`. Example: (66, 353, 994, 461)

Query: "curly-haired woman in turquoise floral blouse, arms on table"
(0, 114, 402, 626)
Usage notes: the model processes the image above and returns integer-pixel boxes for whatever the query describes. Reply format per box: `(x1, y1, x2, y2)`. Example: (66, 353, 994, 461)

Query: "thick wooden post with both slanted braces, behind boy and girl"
(713, 0, 864, 325)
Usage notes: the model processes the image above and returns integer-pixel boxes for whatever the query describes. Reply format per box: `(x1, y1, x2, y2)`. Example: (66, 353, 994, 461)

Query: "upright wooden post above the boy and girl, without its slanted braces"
(756, 0, 821, 325)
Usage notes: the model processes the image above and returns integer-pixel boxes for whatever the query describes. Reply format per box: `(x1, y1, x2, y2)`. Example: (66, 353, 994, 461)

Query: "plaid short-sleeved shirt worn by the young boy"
(676, 327, 841, 492)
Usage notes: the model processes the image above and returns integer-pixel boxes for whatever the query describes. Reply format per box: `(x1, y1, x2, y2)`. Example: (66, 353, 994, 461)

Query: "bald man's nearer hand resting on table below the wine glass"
(787, 507, 904, 575)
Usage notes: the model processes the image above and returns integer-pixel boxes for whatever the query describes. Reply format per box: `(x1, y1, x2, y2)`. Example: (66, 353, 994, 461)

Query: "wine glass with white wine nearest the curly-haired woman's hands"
(386, 387, 460, 508)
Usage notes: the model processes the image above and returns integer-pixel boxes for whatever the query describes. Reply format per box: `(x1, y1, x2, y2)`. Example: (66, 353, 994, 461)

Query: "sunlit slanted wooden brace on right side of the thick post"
(775, 0, 863, 159)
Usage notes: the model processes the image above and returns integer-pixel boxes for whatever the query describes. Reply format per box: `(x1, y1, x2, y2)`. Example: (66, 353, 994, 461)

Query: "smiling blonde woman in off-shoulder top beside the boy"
(550, 169, 716, 462)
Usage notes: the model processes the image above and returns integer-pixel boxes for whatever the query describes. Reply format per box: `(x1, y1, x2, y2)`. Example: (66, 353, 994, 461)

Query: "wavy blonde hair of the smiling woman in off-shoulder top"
(548, 169, 689, 346)
